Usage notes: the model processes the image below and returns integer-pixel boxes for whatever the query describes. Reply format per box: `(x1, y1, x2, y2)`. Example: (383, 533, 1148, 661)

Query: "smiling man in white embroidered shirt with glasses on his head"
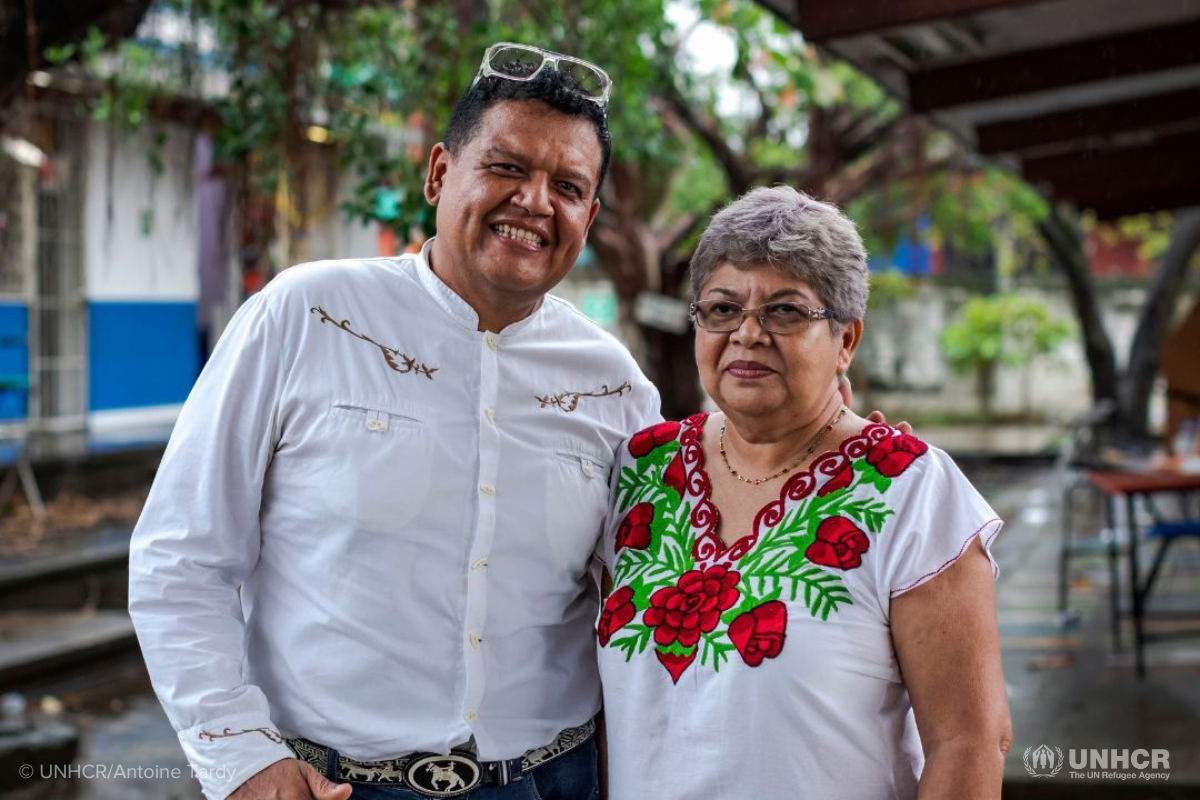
(130, 44, 659, 800)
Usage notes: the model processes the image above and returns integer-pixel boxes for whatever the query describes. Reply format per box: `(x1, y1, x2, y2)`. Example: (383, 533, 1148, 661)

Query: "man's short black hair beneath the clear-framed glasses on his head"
(443, 67, 612, 196)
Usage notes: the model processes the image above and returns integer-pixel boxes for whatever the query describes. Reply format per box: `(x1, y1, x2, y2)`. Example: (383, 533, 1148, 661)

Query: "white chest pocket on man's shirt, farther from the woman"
(328, 402, 430, 533)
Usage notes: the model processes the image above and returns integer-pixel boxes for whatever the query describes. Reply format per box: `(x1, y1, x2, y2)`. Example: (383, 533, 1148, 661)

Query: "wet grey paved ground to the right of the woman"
(973, 469, 1200, 798)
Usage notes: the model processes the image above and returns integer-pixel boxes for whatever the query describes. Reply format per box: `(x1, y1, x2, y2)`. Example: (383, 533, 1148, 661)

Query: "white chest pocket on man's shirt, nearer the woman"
(545, 441, 612, 575)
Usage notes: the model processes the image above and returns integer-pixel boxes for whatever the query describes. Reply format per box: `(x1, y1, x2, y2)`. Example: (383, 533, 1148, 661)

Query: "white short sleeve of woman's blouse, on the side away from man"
(876, 447, 1003, 608)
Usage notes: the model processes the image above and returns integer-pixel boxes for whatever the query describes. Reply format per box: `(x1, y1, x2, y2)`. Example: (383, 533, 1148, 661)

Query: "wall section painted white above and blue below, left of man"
(83, 122, 200, 413)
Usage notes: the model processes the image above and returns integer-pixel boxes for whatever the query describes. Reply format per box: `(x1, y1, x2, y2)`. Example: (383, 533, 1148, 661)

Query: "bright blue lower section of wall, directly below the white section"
(88, 301, 200, 411)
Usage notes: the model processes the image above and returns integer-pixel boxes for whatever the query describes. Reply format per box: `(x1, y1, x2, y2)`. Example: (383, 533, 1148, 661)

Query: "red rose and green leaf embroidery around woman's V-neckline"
(596, 414, 929, 682)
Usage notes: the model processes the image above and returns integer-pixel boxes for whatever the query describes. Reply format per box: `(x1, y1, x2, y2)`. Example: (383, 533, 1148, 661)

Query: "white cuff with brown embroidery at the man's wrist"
(179, 714, 295, 800)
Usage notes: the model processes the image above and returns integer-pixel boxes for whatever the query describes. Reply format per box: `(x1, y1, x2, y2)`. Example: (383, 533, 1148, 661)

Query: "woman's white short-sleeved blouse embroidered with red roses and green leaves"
(596, 415, 1002, 800)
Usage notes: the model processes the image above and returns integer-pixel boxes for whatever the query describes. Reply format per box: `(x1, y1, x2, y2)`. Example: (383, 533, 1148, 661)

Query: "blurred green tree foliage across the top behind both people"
(56, 0, 1038, 268)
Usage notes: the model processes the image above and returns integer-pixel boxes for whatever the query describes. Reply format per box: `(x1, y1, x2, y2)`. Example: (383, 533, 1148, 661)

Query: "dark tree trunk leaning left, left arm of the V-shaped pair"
(1038, 205, 1120, 403)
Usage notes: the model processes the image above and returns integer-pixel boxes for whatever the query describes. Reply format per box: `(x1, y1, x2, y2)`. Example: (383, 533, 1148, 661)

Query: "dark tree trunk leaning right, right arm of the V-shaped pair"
(1118, 207, 1200, 437)
